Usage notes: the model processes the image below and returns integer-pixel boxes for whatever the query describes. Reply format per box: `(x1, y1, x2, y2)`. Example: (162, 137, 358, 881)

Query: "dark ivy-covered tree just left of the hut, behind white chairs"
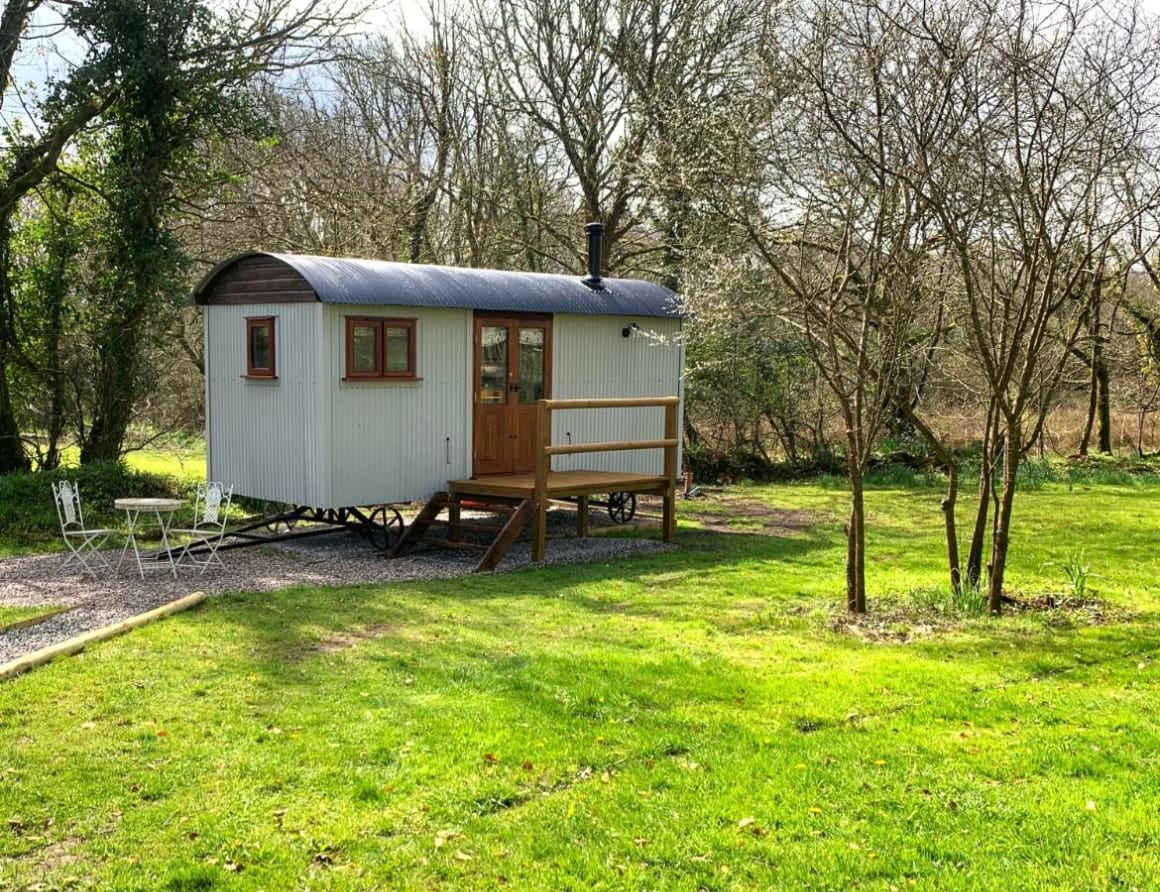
(68, 0, 348, 462)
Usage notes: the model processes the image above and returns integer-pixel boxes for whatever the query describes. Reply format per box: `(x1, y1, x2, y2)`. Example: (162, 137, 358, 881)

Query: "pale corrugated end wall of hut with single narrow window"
(205, 303, 329, 505)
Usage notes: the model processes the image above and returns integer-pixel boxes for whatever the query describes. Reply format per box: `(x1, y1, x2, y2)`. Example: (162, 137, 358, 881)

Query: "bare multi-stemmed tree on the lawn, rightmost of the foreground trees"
(930, 0, 1158, 612)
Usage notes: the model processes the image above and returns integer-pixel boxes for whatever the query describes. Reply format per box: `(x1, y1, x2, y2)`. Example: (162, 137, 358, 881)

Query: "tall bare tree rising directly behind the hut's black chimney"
(473, 0, 759, 275)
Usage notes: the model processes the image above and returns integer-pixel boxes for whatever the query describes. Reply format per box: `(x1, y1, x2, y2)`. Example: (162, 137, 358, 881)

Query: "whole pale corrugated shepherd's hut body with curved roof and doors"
(194, 254, 684, 508)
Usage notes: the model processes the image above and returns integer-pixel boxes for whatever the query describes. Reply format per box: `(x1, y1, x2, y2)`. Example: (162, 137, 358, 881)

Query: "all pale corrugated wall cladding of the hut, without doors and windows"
(205, 303, 684, 508)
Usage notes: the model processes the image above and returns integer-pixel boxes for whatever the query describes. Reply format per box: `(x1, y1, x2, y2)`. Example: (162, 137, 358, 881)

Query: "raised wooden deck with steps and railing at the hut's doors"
(391, 397, 680, 571)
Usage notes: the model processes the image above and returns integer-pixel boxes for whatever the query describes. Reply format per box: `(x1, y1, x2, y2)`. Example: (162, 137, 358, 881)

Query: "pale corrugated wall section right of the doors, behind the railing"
(552, 313, 684, 473)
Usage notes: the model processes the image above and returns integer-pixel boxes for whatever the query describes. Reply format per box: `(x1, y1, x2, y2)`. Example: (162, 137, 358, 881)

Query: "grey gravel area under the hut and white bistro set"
(0, 512, 673, 663)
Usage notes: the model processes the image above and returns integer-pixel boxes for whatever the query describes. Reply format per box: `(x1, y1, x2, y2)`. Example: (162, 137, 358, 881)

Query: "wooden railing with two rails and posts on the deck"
(531, 397, 681, 560)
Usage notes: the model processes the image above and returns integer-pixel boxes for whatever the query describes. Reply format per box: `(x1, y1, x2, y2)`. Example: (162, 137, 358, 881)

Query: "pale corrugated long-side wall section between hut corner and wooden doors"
(324, 304, 473, 507)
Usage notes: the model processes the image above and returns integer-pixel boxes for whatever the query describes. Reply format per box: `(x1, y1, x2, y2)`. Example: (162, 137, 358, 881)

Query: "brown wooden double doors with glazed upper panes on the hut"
(473, 314, 552, 477)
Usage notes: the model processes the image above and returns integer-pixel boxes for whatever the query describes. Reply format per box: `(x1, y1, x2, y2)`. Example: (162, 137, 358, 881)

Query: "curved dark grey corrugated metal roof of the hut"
(194, 252, 683, 317)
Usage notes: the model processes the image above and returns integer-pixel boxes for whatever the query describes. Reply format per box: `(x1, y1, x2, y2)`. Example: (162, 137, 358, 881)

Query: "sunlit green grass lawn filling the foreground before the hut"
(0, 485, 1160, 890)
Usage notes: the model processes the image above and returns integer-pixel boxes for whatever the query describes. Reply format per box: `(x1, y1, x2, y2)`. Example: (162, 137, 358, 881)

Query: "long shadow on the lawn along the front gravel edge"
(196, 530, 834, 683)
